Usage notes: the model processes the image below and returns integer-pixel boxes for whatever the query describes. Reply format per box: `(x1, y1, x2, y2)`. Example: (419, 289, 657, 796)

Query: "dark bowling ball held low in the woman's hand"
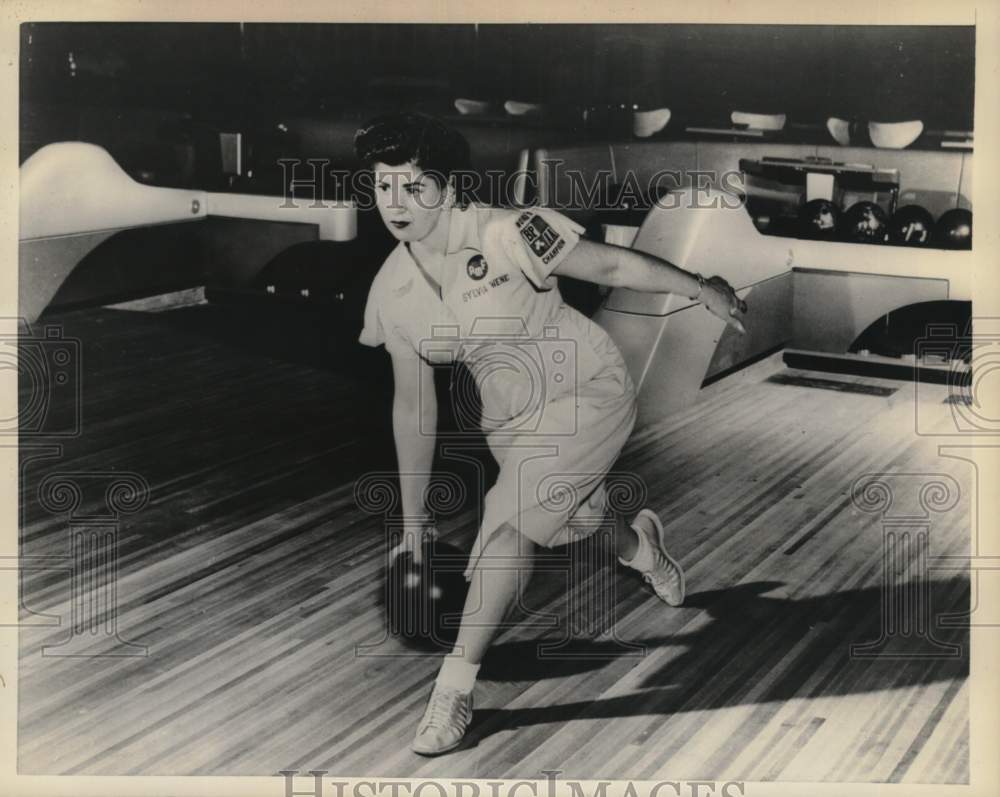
(385, 540, 469, 649)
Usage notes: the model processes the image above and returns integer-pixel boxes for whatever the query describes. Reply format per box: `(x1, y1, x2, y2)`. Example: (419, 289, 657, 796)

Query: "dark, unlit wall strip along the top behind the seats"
(21, 23, 975, 145)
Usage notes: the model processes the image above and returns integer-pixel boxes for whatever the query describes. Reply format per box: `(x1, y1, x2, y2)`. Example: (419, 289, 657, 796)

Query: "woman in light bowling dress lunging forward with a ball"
(355, 113, 746, 755)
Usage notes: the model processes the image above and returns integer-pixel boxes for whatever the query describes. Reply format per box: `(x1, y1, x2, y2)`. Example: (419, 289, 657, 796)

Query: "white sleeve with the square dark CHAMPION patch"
(487, 208, 584, 291)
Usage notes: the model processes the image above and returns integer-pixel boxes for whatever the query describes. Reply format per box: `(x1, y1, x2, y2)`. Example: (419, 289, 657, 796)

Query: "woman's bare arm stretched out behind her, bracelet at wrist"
(554, 240, 746, 332)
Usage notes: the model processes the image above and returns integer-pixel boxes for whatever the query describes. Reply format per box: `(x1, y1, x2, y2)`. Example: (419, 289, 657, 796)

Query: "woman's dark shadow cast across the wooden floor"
(467, 579, 969, 747)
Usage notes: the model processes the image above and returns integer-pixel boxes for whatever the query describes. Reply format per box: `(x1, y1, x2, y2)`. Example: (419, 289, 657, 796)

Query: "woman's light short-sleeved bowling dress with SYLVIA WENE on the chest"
(359, 206, 635, 556)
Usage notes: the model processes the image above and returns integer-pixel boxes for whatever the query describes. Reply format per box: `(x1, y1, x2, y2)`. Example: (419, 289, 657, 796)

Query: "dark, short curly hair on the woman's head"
(354, 111, 471, 188)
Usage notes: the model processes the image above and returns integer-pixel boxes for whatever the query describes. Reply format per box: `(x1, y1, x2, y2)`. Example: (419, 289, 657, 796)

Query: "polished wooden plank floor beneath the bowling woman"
(18, 307, 971, 783)
